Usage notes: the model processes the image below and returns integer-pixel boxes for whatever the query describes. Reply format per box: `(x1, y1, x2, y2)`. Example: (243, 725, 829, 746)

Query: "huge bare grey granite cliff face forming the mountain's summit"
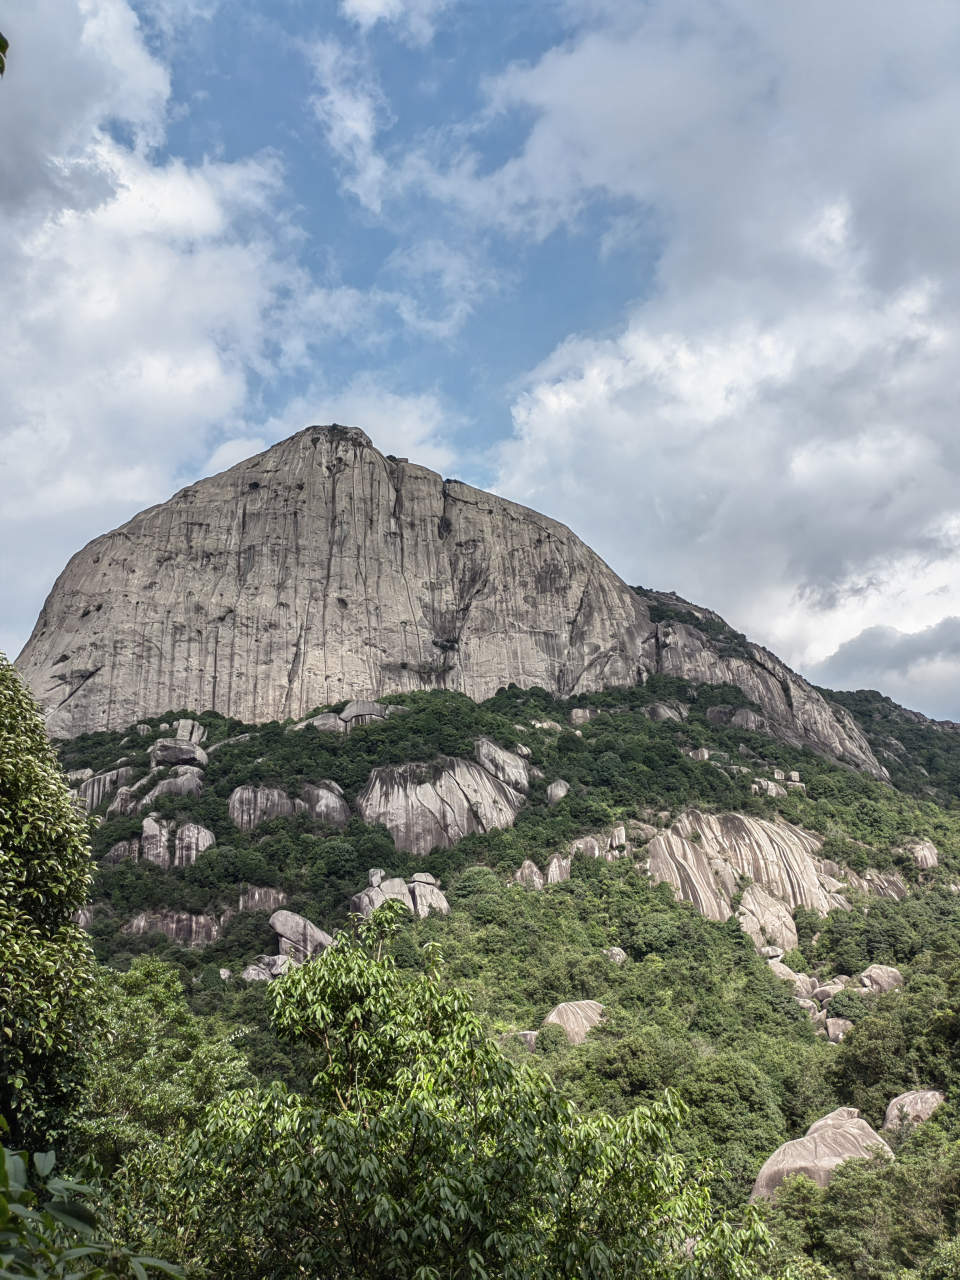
(17, 426, 882, 774)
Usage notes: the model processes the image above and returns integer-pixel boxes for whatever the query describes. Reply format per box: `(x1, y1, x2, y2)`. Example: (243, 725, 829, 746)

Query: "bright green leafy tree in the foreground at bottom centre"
(129, 904, 767, 1280)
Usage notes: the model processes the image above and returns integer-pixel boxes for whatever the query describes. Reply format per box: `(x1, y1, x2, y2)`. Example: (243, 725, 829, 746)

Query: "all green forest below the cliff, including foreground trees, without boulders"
(0, 650, 960, 1280)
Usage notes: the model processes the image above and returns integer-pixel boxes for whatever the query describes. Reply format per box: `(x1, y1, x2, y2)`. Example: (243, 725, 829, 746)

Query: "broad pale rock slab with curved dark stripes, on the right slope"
(645, 809, 906, 952)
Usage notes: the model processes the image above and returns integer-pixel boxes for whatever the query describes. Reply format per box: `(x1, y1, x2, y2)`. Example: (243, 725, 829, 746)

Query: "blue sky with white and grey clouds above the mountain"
(0, 0, 960, 721)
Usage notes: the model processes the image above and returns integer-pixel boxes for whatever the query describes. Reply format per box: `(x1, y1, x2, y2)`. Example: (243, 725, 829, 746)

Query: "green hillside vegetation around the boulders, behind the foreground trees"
(5, 634, 960, 1280)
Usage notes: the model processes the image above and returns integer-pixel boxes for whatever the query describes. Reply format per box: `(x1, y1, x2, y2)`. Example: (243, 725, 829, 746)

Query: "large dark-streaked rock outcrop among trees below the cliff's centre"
(357, 739, 527, 854)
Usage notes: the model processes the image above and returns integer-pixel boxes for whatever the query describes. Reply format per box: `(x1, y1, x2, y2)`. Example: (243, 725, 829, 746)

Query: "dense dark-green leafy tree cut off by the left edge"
(0, 654, 93, 1146)
